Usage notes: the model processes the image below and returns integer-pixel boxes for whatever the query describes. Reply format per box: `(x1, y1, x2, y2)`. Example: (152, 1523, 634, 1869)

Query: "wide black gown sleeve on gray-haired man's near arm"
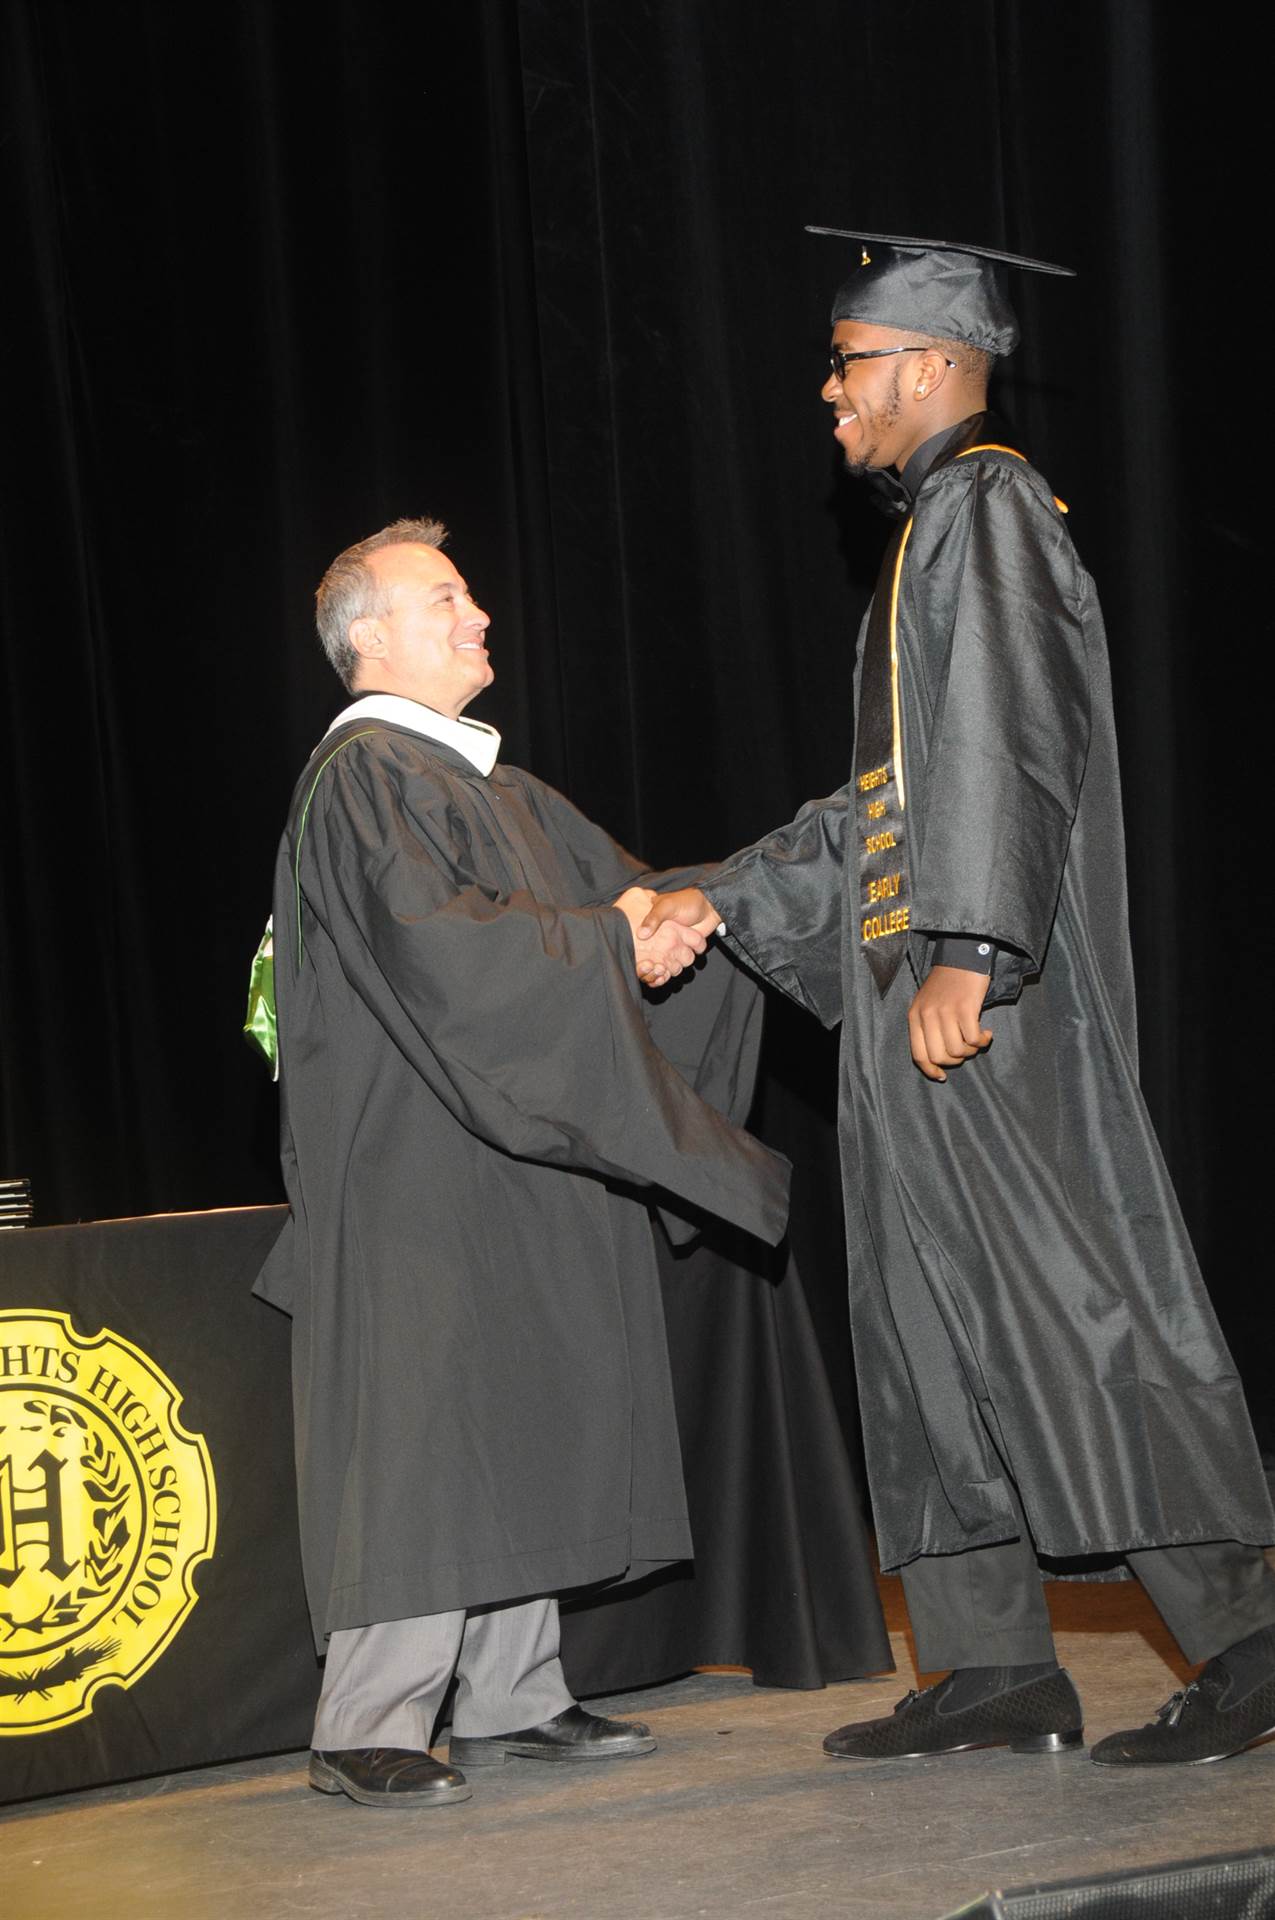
(291, 741, 791, 1242)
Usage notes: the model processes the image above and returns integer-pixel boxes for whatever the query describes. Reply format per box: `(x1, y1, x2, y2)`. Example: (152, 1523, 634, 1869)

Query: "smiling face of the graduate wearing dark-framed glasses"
(820, 321, 970, 472)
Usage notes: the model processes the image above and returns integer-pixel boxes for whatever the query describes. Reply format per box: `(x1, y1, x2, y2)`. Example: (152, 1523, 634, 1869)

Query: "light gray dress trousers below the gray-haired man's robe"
(311, 1599, 574, 1753)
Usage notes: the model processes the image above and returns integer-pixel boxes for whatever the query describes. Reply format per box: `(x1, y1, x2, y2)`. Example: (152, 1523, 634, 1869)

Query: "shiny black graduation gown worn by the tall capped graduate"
(710, 422, 1275, 1567)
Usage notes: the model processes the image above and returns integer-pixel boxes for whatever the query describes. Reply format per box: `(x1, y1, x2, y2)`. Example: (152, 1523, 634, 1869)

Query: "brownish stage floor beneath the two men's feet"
(0, 1580, 1275, 1920)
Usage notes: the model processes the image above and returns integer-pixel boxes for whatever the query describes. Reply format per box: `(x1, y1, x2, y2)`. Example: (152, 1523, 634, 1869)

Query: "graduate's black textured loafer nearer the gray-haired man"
(824, 1667, 1085, 1761)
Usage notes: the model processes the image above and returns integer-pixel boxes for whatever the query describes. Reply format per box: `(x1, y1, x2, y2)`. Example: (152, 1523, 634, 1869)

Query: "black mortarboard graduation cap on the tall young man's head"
(806, 227, 1075, 353)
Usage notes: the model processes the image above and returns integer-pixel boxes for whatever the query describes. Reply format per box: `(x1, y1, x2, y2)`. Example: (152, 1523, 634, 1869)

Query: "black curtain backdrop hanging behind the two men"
(0, 0, 1275, 1442)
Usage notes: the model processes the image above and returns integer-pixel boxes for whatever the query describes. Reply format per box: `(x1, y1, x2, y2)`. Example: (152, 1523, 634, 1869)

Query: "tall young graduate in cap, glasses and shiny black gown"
(647, 228, 1275, 1764)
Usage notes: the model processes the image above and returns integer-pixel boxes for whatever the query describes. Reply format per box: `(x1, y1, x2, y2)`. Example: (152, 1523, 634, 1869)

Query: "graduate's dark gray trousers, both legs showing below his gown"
(901, 1488, 1275, 1672)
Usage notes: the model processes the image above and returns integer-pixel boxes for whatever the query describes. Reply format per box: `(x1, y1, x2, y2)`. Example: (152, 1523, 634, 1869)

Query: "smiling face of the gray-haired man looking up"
(349, 543, 495, 720)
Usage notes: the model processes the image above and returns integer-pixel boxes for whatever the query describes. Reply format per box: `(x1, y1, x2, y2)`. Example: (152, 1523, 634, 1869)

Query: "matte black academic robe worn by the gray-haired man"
(257, 718, 789, 1644)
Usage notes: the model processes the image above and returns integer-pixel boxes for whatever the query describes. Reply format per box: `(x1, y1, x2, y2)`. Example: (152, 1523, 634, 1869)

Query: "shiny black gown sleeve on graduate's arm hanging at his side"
(910, 461, 1089, 1004)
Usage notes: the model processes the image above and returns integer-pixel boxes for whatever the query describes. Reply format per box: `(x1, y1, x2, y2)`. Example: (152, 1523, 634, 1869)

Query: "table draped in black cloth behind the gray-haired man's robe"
(0, 1208, 891, 1801)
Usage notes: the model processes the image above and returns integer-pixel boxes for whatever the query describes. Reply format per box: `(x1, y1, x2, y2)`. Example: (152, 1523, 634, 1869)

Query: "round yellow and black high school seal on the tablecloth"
(0, 1308, 217, 1736)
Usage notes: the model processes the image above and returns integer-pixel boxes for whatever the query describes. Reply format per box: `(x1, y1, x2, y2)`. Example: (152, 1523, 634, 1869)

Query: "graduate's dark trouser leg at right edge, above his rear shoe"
(1125, 1540, 1275, 1667)
